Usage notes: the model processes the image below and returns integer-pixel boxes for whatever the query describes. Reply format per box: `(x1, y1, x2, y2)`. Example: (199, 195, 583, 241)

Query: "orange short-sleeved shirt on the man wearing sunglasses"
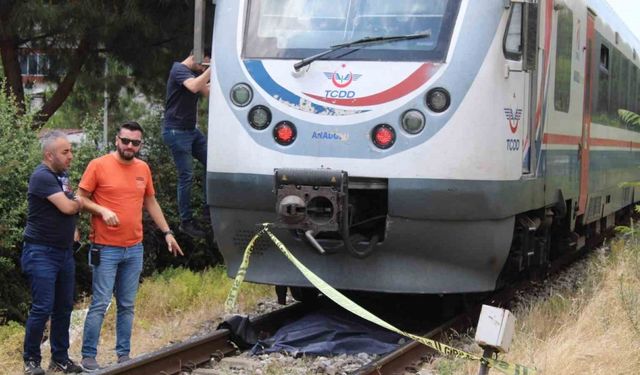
(78, 153, 155, 247)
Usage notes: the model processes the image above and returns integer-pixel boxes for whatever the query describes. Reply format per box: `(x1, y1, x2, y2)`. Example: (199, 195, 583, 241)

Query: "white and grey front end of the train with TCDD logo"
(207, 0, 522, 293)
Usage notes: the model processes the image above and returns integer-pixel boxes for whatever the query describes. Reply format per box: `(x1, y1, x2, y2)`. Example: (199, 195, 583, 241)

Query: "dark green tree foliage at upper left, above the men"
(0, 0, 202, 129)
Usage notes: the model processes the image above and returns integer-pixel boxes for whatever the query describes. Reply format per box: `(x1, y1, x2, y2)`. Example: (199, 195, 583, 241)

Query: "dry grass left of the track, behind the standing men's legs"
(0, 267, 273, 374)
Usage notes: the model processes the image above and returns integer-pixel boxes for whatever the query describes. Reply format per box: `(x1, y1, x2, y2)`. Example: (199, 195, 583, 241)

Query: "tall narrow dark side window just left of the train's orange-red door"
(554, 8, 573, 112)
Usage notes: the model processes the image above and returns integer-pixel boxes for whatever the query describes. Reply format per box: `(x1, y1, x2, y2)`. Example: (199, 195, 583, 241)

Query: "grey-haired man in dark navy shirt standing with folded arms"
(21, 131, 82, 374)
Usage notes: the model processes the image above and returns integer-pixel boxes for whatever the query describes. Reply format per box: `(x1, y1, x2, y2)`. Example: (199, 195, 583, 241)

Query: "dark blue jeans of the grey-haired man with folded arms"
(21, 242, 76, 362)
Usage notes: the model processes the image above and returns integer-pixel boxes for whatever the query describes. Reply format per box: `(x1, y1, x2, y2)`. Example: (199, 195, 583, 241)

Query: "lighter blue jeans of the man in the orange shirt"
(82, 243, 143, 358)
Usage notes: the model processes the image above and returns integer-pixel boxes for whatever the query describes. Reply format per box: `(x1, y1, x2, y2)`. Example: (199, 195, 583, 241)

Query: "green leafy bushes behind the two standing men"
(0, 87, 220, 324)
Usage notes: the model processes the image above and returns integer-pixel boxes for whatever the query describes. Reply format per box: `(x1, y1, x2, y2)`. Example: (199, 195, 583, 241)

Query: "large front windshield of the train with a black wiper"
(243, 0, 460, 61)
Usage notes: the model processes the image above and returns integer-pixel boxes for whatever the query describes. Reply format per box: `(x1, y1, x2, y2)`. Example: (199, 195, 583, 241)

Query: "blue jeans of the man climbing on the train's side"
(162, 129, 207, 221)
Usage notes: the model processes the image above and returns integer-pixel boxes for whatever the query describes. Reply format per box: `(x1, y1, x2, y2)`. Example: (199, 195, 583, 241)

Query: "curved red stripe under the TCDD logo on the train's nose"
(304, 63, 438, 107)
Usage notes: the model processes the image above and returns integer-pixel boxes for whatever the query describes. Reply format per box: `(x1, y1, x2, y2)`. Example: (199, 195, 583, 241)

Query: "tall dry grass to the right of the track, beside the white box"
(429, 241, 640, 375)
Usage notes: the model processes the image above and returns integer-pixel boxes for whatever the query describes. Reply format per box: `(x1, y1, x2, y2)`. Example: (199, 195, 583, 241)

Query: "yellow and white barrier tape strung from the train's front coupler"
(225, 224, 537, 375)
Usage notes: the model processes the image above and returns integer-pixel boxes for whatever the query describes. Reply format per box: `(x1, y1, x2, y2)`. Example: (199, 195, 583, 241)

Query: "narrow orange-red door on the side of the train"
(577, 10, 595, 215)
